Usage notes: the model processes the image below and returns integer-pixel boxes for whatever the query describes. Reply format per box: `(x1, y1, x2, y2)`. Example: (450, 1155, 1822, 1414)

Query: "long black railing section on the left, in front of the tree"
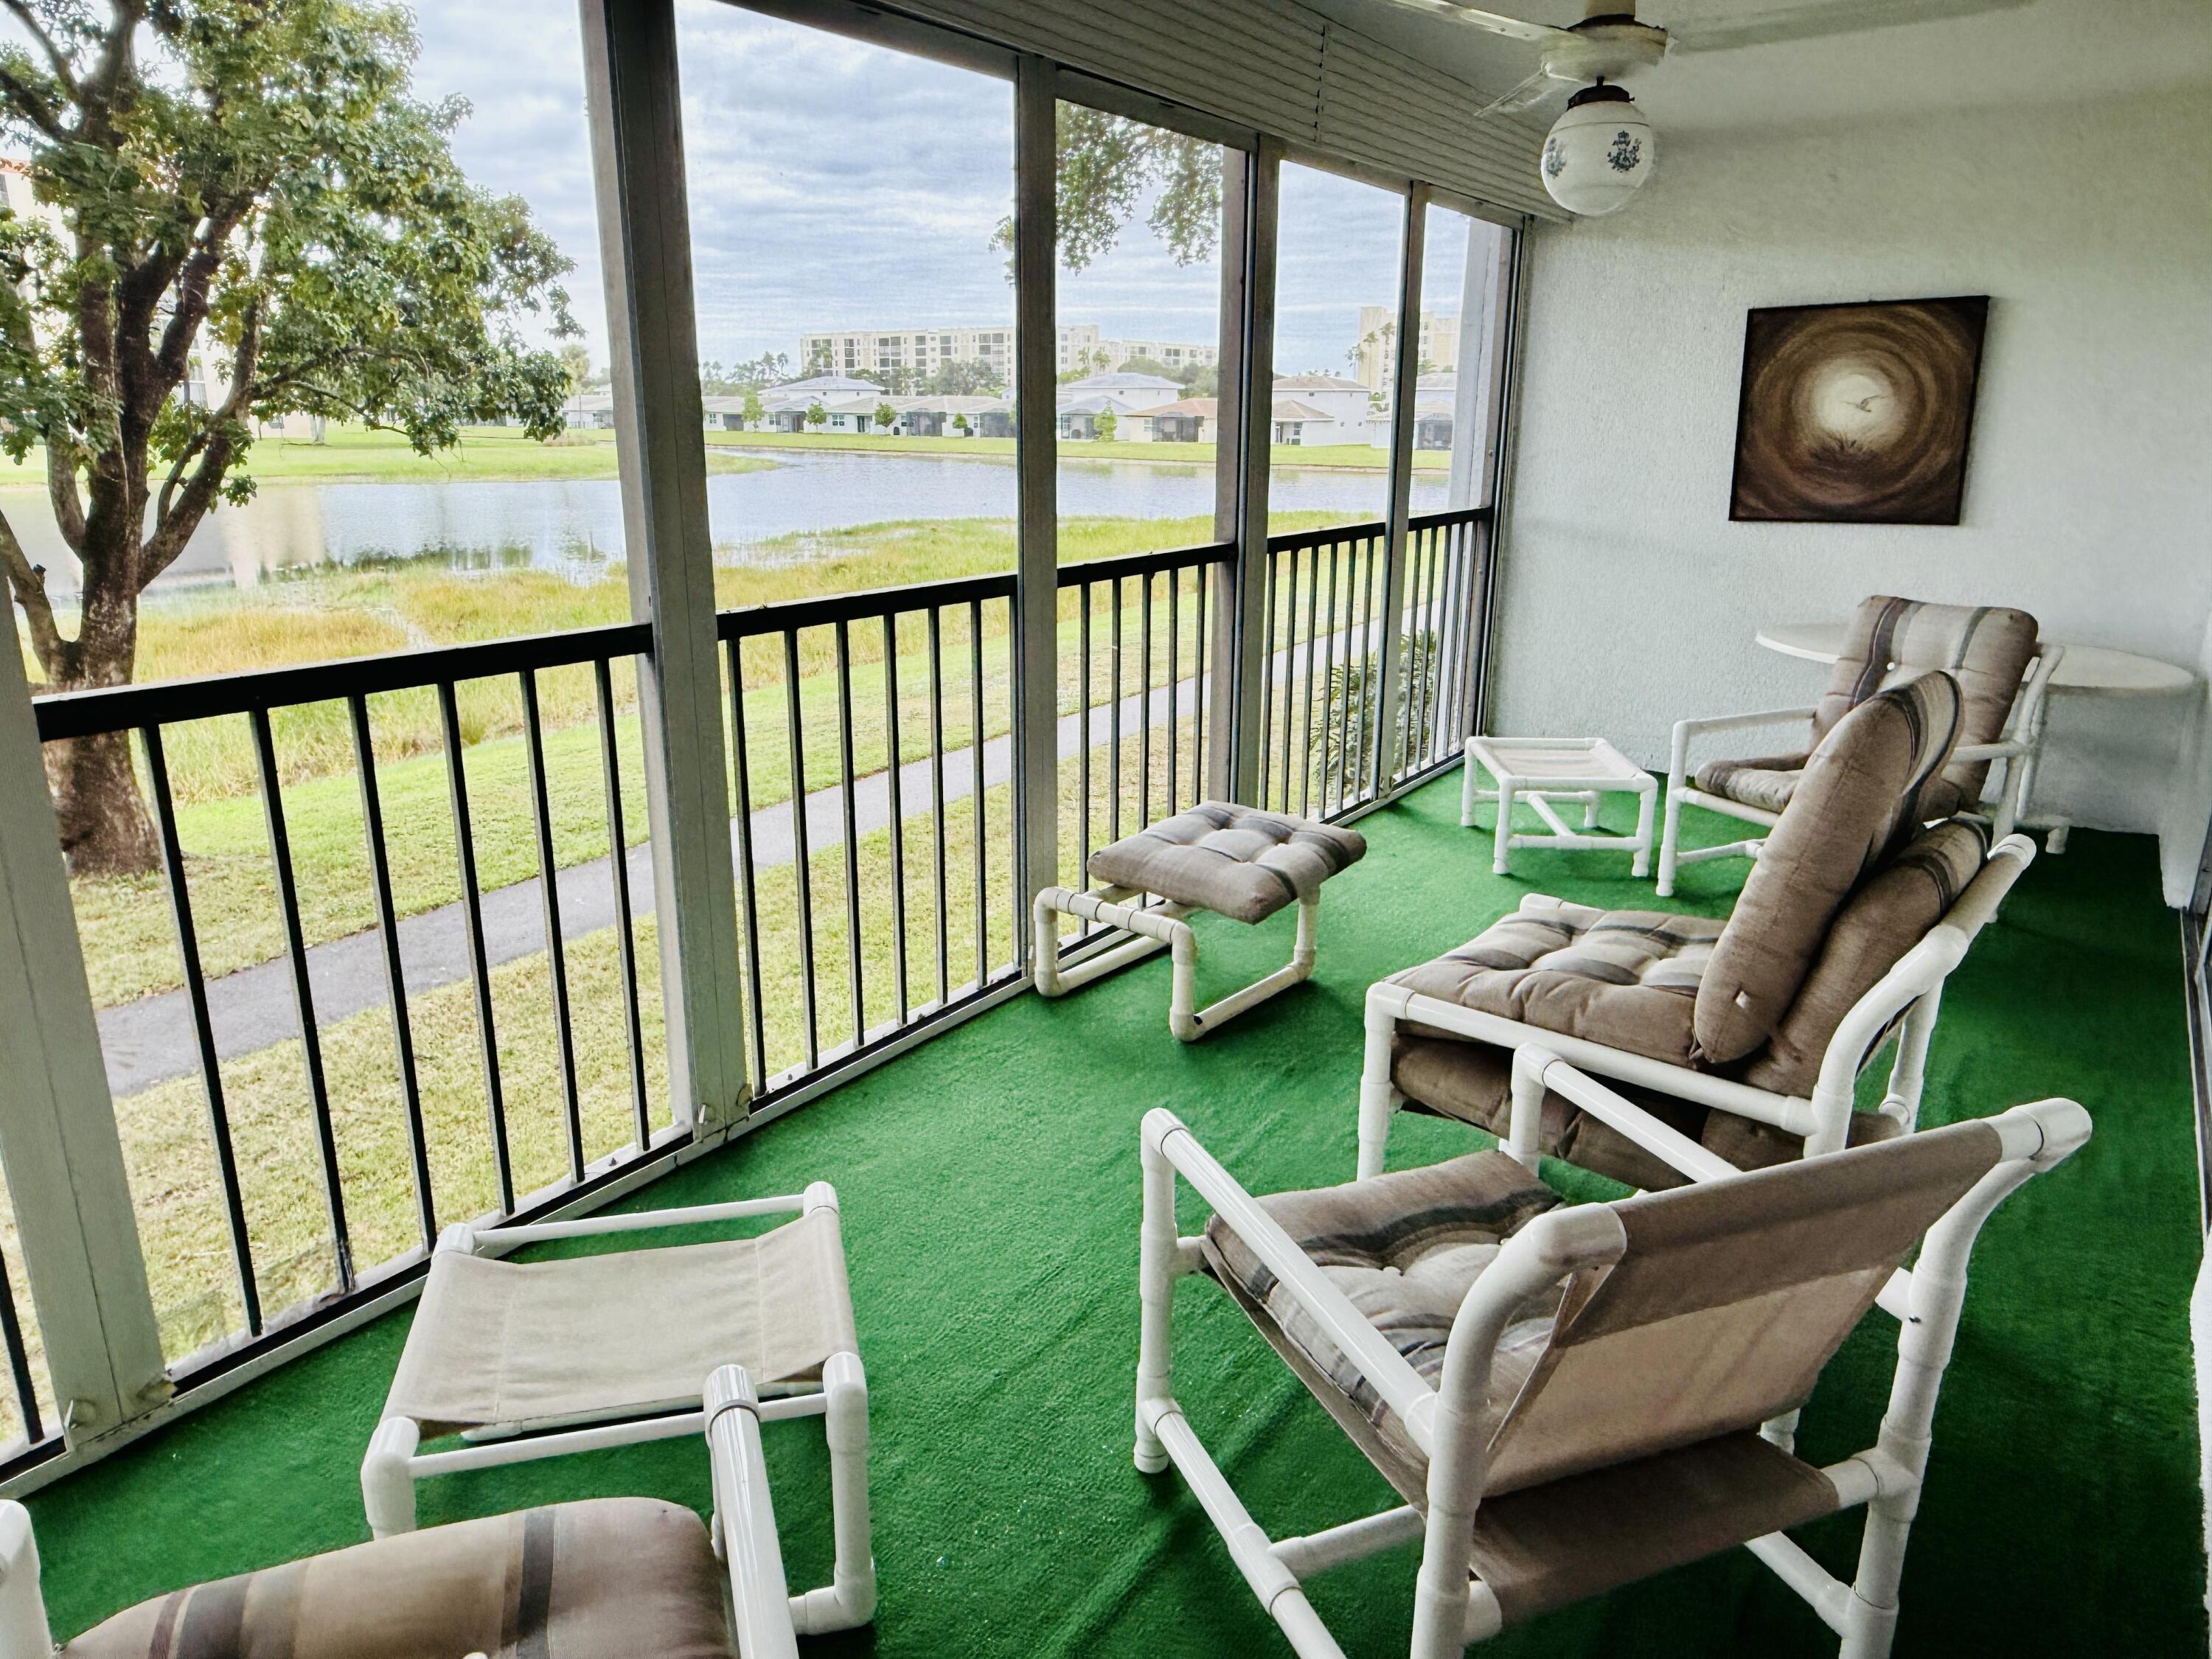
(36, 624, 659, 1360)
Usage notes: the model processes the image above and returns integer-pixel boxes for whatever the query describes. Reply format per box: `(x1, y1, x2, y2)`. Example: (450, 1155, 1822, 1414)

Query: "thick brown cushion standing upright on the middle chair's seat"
(1690, 672, 1960, 1064)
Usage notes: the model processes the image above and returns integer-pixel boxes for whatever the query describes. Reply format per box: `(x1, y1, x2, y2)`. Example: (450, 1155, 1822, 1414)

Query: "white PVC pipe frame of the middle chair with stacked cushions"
(1358, 834, 2035, 1177)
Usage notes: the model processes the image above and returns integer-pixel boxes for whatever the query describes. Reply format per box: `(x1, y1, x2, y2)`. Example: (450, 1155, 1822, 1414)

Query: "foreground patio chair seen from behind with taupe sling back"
(1137, 1093, 2090, 1659)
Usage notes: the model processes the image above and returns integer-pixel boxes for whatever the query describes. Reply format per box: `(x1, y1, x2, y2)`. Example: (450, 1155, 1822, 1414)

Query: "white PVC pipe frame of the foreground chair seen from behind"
(1135, 1093, 2090, 1659)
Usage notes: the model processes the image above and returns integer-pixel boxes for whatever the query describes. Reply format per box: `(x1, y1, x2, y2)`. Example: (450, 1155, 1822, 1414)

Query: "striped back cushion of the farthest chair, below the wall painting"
(1812, 593, 2037, 818)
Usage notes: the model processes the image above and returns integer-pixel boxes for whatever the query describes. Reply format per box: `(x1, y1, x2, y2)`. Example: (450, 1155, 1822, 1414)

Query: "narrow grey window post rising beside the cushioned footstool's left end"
(1013, 58, 1057, 969)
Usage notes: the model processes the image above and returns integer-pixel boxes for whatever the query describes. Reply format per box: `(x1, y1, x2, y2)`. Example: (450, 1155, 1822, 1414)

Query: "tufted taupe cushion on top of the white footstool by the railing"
(1091, 801, 1367, 922)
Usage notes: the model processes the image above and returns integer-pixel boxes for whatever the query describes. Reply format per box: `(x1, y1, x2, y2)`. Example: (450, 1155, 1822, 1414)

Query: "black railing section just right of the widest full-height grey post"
(719, 573, 1022, 1097)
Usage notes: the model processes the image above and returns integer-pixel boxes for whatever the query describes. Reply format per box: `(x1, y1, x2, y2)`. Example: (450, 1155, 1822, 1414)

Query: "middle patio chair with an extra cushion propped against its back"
(1358, 672, 2035, 1188)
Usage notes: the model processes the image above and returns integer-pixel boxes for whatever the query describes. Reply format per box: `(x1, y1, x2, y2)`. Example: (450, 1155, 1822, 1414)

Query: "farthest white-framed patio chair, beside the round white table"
(1659, 593, 2064, 898)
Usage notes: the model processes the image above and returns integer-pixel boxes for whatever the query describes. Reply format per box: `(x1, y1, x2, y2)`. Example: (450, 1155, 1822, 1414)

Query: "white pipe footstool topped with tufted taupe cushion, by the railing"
(1033, 801, 1367, 1042)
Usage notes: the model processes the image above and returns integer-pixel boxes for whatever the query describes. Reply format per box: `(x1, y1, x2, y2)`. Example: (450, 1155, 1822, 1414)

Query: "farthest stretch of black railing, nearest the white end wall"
(1259, 509, 1489, 818)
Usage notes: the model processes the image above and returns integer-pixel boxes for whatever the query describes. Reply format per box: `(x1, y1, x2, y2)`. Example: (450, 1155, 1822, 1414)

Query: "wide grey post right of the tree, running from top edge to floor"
(582, 0, 750, 1133)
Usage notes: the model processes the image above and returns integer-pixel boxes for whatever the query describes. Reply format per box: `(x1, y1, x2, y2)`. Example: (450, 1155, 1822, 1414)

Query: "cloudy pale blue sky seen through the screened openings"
(416, 0, 1464, 374)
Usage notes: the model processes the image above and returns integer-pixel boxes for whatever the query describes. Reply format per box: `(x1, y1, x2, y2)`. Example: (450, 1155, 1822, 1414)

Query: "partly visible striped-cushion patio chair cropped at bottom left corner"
(0, 1365, 799, 1659)
